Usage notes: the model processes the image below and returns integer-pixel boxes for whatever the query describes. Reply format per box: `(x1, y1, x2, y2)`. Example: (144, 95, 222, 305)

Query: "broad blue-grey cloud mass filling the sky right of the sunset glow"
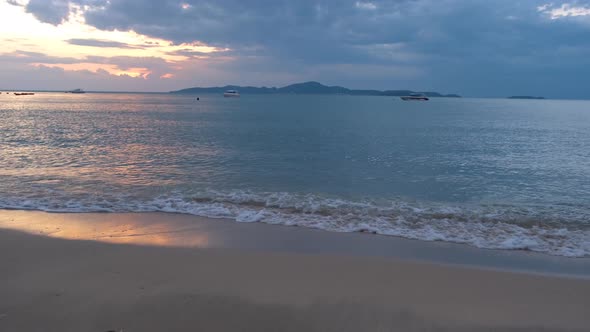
(13, 0, 590, 97)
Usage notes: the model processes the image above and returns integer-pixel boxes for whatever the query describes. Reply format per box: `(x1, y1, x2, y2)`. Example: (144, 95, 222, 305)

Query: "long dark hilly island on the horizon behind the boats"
(170, 82, 461, 98)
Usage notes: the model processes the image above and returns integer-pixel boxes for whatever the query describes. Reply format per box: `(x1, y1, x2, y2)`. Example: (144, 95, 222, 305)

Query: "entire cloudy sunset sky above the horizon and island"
(0, 0, 590, 99)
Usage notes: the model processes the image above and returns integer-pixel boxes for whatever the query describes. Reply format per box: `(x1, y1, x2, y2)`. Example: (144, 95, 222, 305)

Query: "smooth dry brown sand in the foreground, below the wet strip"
(0, 214, 590, 331)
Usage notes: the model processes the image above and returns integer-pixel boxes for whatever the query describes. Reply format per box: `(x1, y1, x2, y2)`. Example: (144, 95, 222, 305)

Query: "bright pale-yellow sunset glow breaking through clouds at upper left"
(0, 1, 229, 79)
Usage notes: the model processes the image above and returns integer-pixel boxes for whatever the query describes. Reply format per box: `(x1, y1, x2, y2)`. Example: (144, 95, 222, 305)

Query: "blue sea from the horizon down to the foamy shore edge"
(0, 93, 590, 257)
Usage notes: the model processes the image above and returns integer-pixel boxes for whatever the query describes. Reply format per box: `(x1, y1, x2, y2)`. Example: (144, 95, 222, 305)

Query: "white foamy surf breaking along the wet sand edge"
(0, 191, 590, 257)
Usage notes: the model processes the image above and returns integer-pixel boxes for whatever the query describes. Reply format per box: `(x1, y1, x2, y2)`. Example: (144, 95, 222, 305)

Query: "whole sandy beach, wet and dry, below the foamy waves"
(0, 210, 590, 332)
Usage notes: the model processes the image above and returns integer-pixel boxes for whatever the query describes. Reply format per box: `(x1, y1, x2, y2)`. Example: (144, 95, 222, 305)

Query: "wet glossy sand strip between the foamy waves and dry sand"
(0, 209, 590, 279)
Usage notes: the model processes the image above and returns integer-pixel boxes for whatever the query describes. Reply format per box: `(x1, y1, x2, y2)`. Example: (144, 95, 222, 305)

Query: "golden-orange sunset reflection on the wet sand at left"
(0, 210, 210, 248)
